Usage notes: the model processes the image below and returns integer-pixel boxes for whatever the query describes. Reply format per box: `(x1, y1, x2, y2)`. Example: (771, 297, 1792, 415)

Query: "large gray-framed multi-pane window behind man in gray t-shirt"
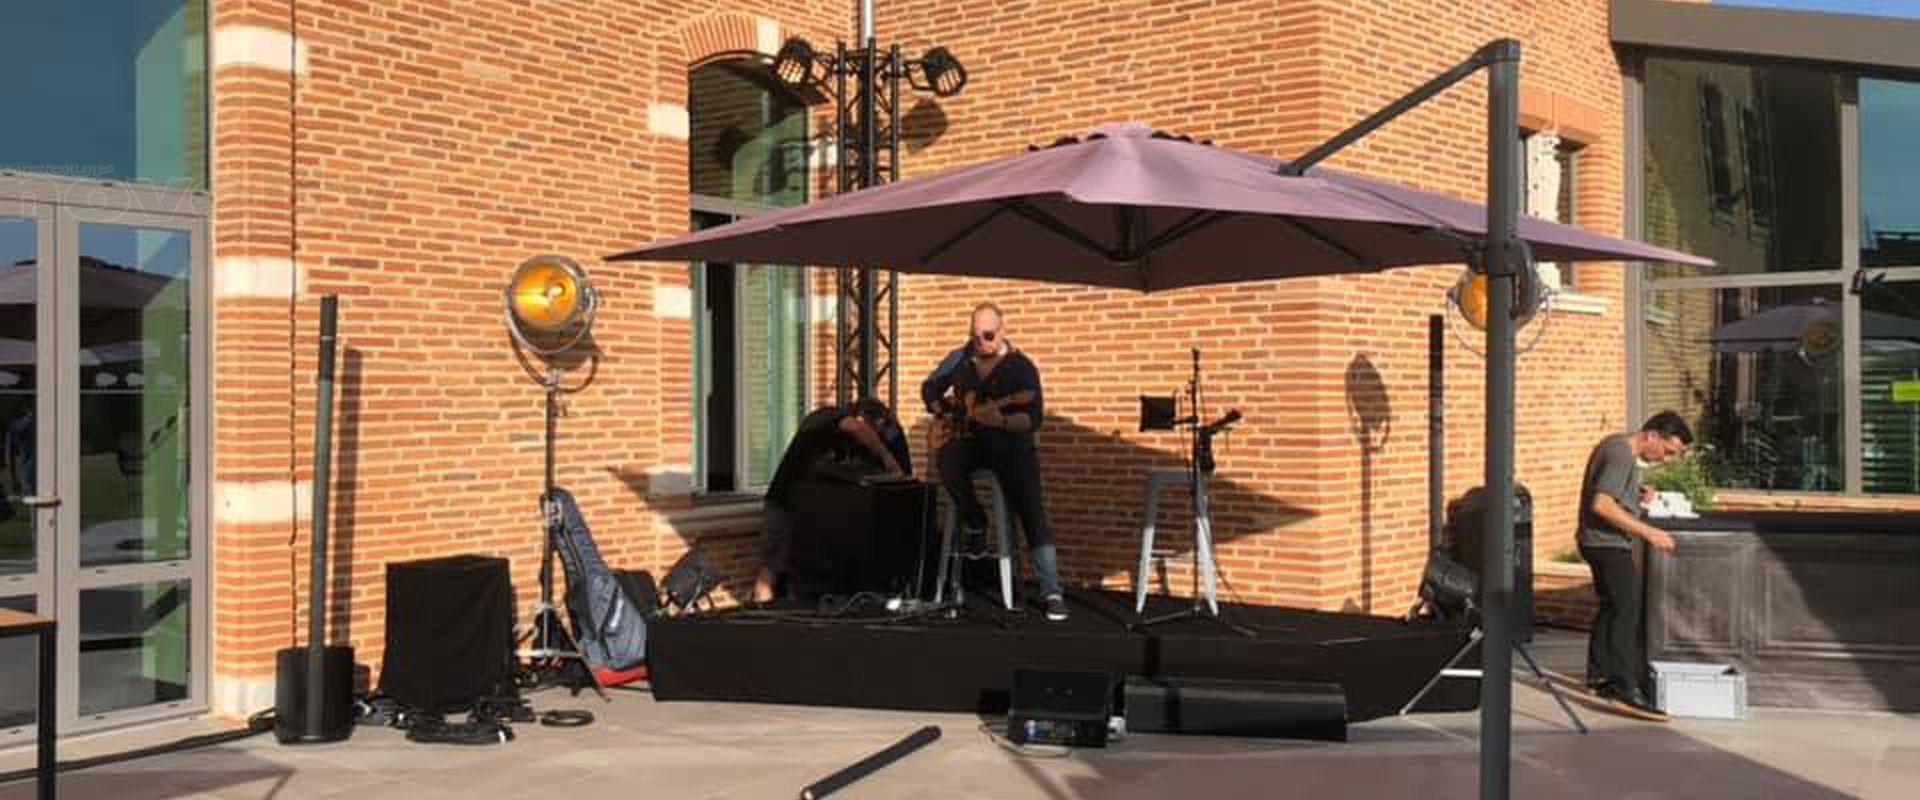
(1636, 58, 1920, 493)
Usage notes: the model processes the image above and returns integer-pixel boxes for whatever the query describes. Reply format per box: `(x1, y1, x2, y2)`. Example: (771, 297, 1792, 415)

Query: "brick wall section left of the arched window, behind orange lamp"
(213, 0, 851, 712)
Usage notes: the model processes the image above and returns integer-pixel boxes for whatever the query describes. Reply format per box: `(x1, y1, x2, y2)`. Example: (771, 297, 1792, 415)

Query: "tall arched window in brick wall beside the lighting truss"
(687, 61, 808, 491)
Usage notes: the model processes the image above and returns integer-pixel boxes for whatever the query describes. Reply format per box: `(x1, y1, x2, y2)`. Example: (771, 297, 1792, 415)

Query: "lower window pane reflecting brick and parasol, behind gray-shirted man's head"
(1644, 286, 1845, 491)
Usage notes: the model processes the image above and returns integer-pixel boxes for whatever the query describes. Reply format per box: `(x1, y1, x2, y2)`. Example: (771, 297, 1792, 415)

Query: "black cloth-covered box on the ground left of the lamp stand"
(380, 556, 513, 712)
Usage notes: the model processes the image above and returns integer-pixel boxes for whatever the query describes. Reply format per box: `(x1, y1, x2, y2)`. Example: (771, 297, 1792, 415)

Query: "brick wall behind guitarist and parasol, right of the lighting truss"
(879, 0, 1628, 614)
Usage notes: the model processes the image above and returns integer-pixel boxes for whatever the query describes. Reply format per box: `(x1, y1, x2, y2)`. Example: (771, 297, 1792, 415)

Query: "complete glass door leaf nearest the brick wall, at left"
(56, 207, 207, 731)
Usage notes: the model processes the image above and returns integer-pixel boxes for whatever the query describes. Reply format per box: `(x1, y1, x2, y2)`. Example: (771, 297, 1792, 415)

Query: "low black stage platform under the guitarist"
(647, 591, 1478, 721)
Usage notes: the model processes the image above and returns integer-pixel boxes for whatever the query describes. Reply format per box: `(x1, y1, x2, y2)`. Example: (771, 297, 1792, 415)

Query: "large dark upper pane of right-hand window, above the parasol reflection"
(1642, 58, 1841, 278)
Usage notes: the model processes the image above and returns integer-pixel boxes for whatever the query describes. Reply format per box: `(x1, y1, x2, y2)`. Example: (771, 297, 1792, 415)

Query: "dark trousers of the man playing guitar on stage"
(933, 439, 1060, 597)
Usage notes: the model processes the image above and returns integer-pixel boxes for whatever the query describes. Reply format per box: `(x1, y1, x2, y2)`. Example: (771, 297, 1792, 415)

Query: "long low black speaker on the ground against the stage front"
(1121, 675, 1346, 742)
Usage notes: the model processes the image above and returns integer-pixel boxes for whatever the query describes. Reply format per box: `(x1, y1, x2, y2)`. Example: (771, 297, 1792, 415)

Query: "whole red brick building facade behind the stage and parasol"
(0, 0, 1912, 729)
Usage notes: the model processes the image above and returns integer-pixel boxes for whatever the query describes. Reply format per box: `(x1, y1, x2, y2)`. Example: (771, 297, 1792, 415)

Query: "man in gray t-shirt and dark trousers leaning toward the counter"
(1576, 411, 1693, 719)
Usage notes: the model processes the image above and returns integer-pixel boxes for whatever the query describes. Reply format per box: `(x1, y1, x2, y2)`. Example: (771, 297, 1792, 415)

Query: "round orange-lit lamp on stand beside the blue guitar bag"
(505, 255, 611, 702)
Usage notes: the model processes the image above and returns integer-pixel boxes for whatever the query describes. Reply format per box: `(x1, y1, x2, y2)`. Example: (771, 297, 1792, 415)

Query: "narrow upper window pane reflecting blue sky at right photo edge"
(1860, 79, 1920, 267)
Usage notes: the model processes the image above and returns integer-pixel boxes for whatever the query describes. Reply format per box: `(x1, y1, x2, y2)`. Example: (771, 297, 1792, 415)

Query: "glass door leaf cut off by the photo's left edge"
(0, 200, 58, 744)
